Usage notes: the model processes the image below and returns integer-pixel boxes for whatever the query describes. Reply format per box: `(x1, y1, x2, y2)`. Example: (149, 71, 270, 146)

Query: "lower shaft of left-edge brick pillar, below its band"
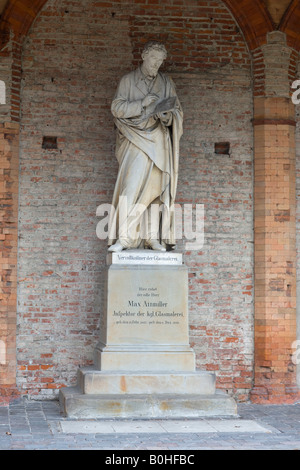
(0, 122, 19, 396)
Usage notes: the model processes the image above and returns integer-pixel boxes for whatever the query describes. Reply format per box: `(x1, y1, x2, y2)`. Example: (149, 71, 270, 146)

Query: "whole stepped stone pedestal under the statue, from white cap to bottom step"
(60, 250, 237, 418)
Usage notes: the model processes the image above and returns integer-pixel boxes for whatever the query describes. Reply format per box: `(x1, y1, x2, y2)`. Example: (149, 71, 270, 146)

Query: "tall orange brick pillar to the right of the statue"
(252, 33, 299, 403)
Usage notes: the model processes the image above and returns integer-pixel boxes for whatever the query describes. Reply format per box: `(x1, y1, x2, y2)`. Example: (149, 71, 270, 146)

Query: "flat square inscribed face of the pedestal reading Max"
(102, 266, 188, 345)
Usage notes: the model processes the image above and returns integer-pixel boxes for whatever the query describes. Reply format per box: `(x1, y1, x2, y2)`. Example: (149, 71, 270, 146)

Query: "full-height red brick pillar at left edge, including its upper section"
(0, 40, 21, 403)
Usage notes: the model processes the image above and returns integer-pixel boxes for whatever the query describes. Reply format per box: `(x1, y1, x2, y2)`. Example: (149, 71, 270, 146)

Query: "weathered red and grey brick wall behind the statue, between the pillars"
(17, 0, 253, 399)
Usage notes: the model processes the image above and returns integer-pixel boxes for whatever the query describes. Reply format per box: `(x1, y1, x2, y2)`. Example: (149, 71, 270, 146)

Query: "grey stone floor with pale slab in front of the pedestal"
(0, 399, 300, 455)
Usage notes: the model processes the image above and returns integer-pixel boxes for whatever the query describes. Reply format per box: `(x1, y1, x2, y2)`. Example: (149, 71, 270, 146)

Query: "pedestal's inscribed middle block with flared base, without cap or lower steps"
(96, 264, 195, 371)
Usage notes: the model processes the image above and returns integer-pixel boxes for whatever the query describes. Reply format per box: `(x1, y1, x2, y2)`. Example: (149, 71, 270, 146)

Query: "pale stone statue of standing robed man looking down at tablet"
(108, 41, 183, 252)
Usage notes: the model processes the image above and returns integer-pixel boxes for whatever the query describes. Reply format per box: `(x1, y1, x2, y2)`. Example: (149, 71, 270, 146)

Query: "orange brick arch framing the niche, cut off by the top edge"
(0, 0, 274, 50)
